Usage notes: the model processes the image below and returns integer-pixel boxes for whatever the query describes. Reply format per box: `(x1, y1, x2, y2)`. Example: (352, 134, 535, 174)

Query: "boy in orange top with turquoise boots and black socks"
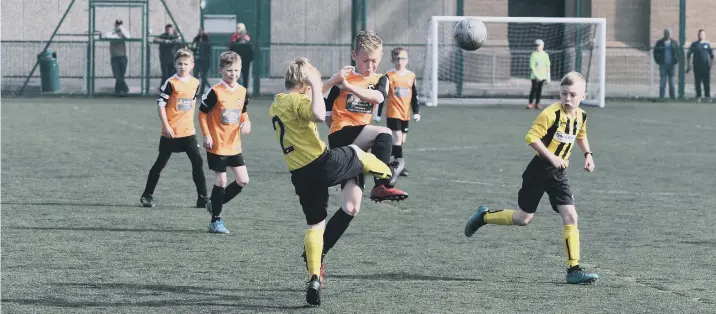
(199, 51, 251, 233)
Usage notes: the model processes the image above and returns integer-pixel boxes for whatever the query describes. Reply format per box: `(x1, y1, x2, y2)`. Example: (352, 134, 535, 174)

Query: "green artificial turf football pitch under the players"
(2, 98, 716, 313)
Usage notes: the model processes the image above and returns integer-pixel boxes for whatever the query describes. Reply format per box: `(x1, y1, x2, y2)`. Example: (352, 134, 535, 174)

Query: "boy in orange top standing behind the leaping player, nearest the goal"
(374, 47, 420, 177)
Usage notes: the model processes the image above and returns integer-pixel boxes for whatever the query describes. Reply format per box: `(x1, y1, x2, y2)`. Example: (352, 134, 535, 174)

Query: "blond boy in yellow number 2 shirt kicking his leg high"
(269, 58, 392, 305)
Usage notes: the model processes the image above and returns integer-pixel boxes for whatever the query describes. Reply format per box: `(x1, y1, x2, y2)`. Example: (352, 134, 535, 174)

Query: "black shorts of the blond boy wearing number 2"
(291, 146, 363, 225)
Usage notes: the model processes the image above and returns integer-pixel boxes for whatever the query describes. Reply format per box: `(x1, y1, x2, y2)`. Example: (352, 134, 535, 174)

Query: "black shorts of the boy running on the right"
(517, 156, 574, 213)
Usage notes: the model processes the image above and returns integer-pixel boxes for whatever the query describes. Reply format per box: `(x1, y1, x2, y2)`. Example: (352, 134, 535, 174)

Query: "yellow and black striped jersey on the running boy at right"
(525, 102, 587, 166)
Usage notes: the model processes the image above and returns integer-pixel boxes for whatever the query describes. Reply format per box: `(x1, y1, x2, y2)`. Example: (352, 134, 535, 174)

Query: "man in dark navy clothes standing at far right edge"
(686, 29, 714, 99)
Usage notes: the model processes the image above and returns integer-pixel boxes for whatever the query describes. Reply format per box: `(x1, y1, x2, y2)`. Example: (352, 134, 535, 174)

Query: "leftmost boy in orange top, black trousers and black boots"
(139, 49, 208, 208)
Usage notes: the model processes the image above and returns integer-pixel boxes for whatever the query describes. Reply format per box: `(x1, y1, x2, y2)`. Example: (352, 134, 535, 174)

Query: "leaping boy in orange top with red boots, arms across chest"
(314, 31, 408, 280)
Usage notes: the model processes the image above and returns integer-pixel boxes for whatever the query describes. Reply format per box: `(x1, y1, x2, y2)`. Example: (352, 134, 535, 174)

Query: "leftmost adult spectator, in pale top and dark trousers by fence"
(102, 20, 131, 95)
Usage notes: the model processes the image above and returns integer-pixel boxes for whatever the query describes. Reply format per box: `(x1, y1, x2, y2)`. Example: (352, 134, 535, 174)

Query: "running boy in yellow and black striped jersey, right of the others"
(465, 72, 599, 284)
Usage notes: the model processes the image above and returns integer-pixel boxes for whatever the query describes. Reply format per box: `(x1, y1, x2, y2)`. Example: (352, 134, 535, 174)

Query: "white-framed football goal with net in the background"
(419, 16, 606, 107)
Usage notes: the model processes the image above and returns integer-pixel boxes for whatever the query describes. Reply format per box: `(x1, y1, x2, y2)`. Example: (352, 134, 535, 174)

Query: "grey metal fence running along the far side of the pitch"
(1, 41, 714, 98)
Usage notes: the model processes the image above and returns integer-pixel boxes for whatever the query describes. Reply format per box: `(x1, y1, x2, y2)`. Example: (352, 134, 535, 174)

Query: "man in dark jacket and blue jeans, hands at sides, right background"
(654, 28, 681, 99)
